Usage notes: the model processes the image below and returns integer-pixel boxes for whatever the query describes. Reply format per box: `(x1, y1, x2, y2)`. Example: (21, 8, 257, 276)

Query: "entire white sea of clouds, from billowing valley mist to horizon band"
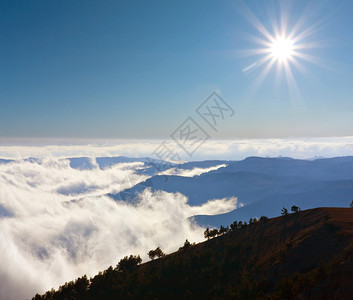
(0, 137, 353, 300)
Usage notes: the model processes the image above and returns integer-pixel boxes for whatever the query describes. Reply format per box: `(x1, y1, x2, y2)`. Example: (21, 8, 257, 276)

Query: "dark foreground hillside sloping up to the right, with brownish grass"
(33, 208, 353, 299)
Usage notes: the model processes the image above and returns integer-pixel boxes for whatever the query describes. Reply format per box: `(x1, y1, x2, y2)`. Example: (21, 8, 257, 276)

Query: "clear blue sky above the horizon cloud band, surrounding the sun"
(0, 0, 353, 139)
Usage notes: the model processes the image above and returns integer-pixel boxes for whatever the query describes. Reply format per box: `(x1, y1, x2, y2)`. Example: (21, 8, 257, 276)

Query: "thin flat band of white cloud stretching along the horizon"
(0, 136, 353, 161)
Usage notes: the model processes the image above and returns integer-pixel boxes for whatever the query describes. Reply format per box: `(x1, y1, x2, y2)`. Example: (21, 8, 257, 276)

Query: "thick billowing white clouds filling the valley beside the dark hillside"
(0, 157, 237, 299)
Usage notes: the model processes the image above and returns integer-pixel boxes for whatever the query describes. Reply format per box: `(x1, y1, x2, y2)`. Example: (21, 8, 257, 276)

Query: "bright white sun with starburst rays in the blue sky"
(241, 2, 323, 98)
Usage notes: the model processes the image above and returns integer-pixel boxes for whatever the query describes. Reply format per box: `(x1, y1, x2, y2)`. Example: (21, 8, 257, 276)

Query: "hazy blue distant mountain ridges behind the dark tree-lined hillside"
(110, 157, 353, 226)
